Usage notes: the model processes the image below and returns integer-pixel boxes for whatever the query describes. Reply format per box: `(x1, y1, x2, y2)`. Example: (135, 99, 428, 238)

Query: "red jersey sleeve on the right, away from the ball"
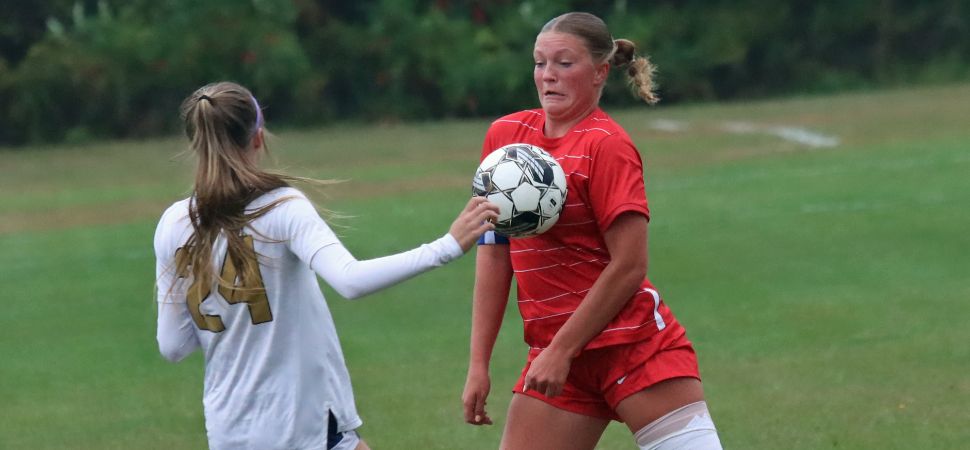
(589, 135, 650, 232)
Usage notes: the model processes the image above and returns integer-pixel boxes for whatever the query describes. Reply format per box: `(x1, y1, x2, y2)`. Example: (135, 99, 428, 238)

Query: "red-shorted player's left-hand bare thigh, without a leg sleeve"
(501, 394, 609, 450)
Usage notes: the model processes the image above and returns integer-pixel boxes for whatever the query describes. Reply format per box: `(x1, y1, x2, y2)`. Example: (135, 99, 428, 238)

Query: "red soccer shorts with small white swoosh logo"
(512, 321, 700, 420)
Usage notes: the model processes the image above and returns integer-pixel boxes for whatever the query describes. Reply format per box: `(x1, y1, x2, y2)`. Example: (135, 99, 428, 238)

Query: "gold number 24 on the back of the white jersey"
(175, 236, 273, 333)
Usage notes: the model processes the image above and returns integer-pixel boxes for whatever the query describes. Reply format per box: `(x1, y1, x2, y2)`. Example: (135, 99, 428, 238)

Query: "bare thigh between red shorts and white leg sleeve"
(616, 377, 704, 433)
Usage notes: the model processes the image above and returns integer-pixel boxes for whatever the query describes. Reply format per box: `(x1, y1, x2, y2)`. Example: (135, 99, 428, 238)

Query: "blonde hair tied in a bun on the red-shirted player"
(540, 12, 660, 105)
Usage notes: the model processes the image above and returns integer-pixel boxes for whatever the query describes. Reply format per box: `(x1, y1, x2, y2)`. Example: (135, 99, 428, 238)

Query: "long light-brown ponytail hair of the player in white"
(175, 82, 295, 296)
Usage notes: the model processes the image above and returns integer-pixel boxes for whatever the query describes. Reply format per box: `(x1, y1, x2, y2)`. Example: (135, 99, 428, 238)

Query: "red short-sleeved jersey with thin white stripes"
(482, 108, 673, 349)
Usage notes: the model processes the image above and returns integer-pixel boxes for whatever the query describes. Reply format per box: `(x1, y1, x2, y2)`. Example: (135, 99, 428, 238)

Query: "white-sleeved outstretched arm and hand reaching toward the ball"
(310, 198, 498, 299)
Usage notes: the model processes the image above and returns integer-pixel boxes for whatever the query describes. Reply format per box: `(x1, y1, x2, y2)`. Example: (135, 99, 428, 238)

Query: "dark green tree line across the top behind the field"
(0, 0, 970, 145)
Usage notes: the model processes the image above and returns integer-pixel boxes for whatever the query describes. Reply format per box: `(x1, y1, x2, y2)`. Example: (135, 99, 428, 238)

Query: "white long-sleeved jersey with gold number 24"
(155, 188, 462, 450)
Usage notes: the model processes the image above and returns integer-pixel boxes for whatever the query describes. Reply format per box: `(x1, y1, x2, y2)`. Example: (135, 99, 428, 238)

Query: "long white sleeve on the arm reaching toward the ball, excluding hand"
(311, 234, 462, 299)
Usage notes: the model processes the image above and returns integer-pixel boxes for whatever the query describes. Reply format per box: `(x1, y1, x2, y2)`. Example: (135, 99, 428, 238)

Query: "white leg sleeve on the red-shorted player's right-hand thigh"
(634, 402, 721, 450)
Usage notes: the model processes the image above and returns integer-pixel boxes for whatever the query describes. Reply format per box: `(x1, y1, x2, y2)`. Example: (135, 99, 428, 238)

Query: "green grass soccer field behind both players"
(0, 85, 970, 449)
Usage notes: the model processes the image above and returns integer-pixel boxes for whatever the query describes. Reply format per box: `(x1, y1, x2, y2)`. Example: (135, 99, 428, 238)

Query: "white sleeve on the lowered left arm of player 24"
(155, 207, 199, 362)
